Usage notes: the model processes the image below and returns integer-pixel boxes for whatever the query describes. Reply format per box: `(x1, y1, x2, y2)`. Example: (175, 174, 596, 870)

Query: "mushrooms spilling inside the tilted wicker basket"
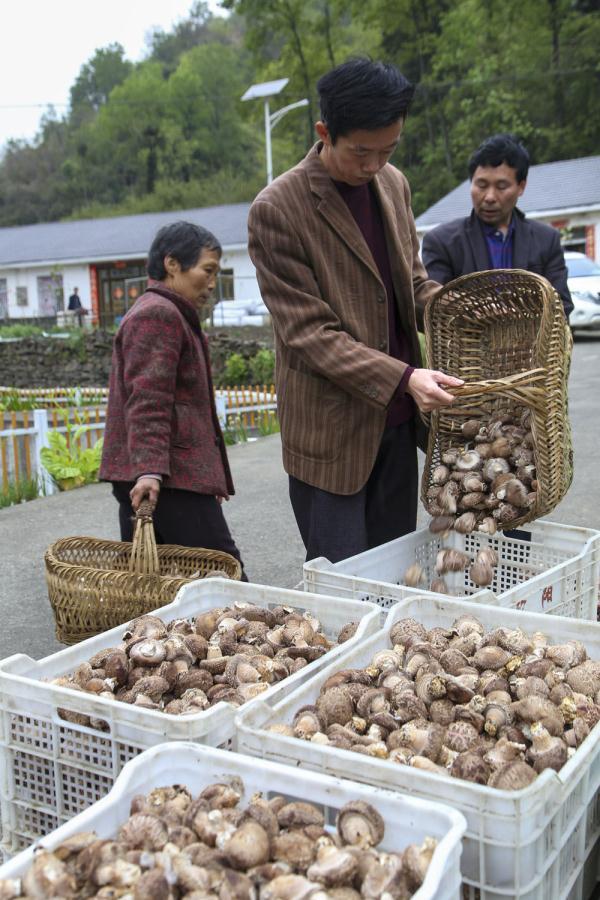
(427, 409, 538, 534)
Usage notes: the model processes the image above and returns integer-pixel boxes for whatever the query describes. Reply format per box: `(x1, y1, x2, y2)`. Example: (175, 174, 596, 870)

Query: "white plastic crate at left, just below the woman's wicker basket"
(0, 578, 381, 856)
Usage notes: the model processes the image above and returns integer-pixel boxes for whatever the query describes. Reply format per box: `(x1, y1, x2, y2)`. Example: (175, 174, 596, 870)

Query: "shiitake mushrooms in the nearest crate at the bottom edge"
(0, 779, 436, 900)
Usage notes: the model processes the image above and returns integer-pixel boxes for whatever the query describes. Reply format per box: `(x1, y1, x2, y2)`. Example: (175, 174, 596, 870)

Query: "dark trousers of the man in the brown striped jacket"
(289, 419, 419, 562)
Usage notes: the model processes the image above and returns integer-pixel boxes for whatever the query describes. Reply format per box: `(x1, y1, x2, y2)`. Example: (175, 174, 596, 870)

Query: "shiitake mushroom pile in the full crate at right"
(270, 615, 600, 790)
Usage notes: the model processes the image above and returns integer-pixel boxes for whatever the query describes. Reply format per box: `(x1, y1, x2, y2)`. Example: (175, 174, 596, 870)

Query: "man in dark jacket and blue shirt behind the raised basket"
(422, 134, 573, 318)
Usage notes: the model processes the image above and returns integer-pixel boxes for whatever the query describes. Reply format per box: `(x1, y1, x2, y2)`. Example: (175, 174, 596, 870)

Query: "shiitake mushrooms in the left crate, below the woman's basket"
(51, 601, 358, 728)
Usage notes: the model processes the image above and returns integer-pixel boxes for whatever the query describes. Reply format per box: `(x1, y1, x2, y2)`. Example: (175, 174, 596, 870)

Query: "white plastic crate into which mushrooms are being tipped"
(304, 521, 600, 620)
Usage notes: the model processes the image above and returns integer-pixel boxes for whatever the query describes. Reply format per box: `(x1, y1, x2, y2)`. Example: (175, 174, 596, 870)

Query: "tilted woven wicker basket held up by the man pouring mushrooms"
(421, 269, 573, 528)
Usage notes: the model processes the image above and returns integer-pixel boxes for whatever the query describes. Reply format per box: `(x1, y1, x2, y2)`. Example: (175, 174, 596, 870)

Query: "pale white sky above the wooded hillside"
(0, 0, 225, 150)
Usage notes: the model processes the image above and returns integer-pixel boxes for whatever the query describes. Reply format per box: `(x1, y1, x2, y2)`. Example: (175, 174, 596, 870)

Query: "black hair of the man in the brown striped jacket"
(317, 57, 415, 144)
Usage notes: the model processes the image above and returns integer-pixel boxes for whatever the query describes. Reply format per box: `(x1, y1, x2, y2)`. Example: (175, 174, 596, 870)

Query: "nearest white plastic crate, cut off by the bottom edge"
(0, 743, 466, 900)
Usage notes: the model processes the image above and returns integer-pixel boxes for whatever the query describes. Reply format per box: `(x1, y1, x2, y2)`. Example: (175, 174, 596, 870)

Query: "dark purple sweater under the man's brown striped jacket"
(334, 181, 415, 427)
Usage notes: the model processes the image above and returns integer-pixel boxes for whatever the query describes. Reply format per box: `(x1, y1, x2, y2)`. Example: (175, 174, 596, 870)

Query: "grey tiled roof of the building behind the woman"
(0, 203, 250, 266)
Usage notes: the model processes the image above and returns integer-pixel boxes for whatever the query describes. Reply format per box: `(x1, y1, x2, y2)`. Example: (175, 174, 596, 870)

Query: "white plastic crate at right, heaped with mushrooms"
(236, 596, 600, 900)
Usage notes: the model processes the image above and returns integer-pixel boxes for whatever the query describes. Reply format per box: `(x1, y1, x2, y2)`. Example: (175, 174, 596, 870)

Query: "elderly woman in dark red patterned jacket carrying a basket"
(100, 222, 247, 580)
